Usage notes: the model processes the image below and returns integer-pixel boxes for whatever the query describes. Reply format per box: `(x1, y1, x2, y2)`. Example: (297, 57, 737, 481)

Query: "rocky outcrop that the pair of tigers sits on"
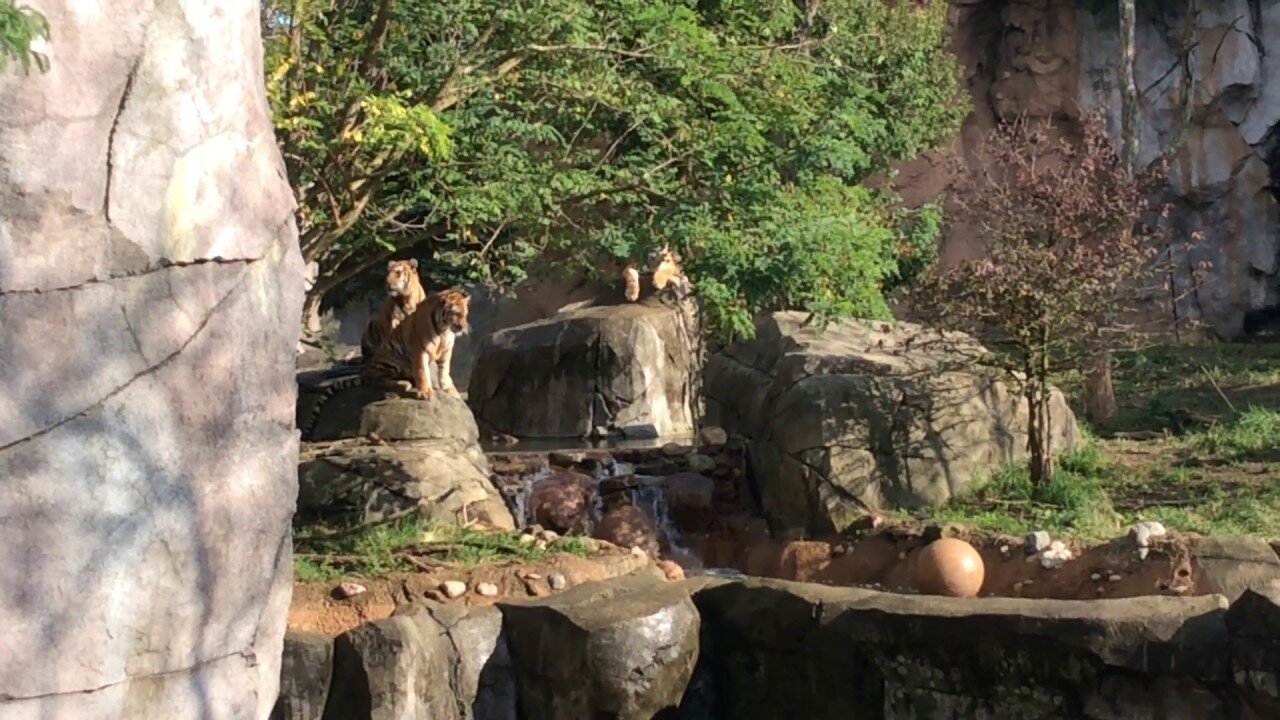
(298, 388, 515, 529)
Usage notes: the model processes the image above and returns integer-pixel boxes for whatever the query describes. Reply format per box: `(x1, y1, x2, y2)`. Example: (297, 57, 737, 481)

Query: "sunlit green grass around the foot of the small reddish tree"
(918, 409, 1280, 541)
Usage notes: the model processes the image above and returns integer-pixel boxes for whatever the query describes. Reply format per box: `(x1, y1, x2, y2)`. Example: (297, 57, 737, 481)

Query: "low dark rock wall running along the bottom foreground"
(276, 573, 1280, 720)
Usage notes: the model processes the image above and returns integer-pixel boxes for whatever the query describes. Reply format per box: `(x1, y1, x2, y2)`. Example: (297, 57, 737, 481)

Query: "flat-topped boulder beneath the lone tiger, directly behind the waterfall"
(467, 301, 696, 438)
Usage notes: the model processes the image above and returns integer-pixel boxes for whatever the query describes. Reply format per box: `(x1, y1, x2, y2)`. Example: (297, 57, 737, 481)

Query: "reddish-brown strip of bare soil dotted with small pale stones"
(289, 551, 649, 635)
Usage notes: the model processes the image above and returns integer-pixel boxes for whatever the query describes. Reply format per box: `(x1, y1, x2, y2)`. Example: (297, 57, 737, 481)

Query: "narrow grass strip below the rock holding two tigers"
(293, 518, 589, 582)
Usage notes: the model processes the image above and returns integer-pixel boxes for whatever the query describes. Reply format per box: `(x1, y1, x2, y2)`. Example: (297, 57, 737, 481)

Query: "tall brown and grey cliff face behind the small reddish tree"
(899, 0, 1280, 338)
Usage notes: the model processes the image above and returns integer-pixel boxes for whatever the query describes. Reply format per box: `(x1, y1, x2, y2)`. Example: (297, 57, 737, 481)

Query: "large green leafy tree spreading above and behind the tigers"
(264, 0, 965, 337)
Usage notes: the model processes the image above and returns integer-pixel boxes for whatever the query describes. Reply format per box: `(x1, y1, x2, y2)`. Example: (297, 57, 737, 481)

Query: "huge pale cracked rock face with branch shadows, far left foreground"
(0, 0, 302, 720)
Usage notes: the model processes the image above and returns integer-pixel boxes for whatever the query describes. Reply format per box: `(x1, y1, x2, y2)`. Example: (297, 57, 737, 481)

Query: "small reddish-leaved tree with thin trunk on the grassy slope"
(913, 111, 1187, 483)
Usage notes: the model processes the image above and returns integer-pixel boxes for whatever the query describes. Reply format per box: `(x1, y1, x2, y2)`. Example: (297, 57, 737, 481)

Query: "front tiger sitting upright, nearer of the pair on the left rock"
(361, 290, 471, 400)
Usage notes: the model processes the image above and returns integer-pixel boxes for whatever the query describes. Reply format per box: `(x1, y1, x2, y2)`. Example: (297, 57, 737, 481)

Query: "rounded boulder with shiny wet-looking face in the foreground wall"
(500, 574, 700, 720)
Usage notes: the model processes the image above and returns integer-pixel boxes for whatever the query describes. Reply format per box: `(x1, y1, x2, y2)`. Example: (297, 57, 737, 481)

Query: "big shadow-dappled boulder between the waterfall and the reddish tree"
(703, 313, 1080, 534)
